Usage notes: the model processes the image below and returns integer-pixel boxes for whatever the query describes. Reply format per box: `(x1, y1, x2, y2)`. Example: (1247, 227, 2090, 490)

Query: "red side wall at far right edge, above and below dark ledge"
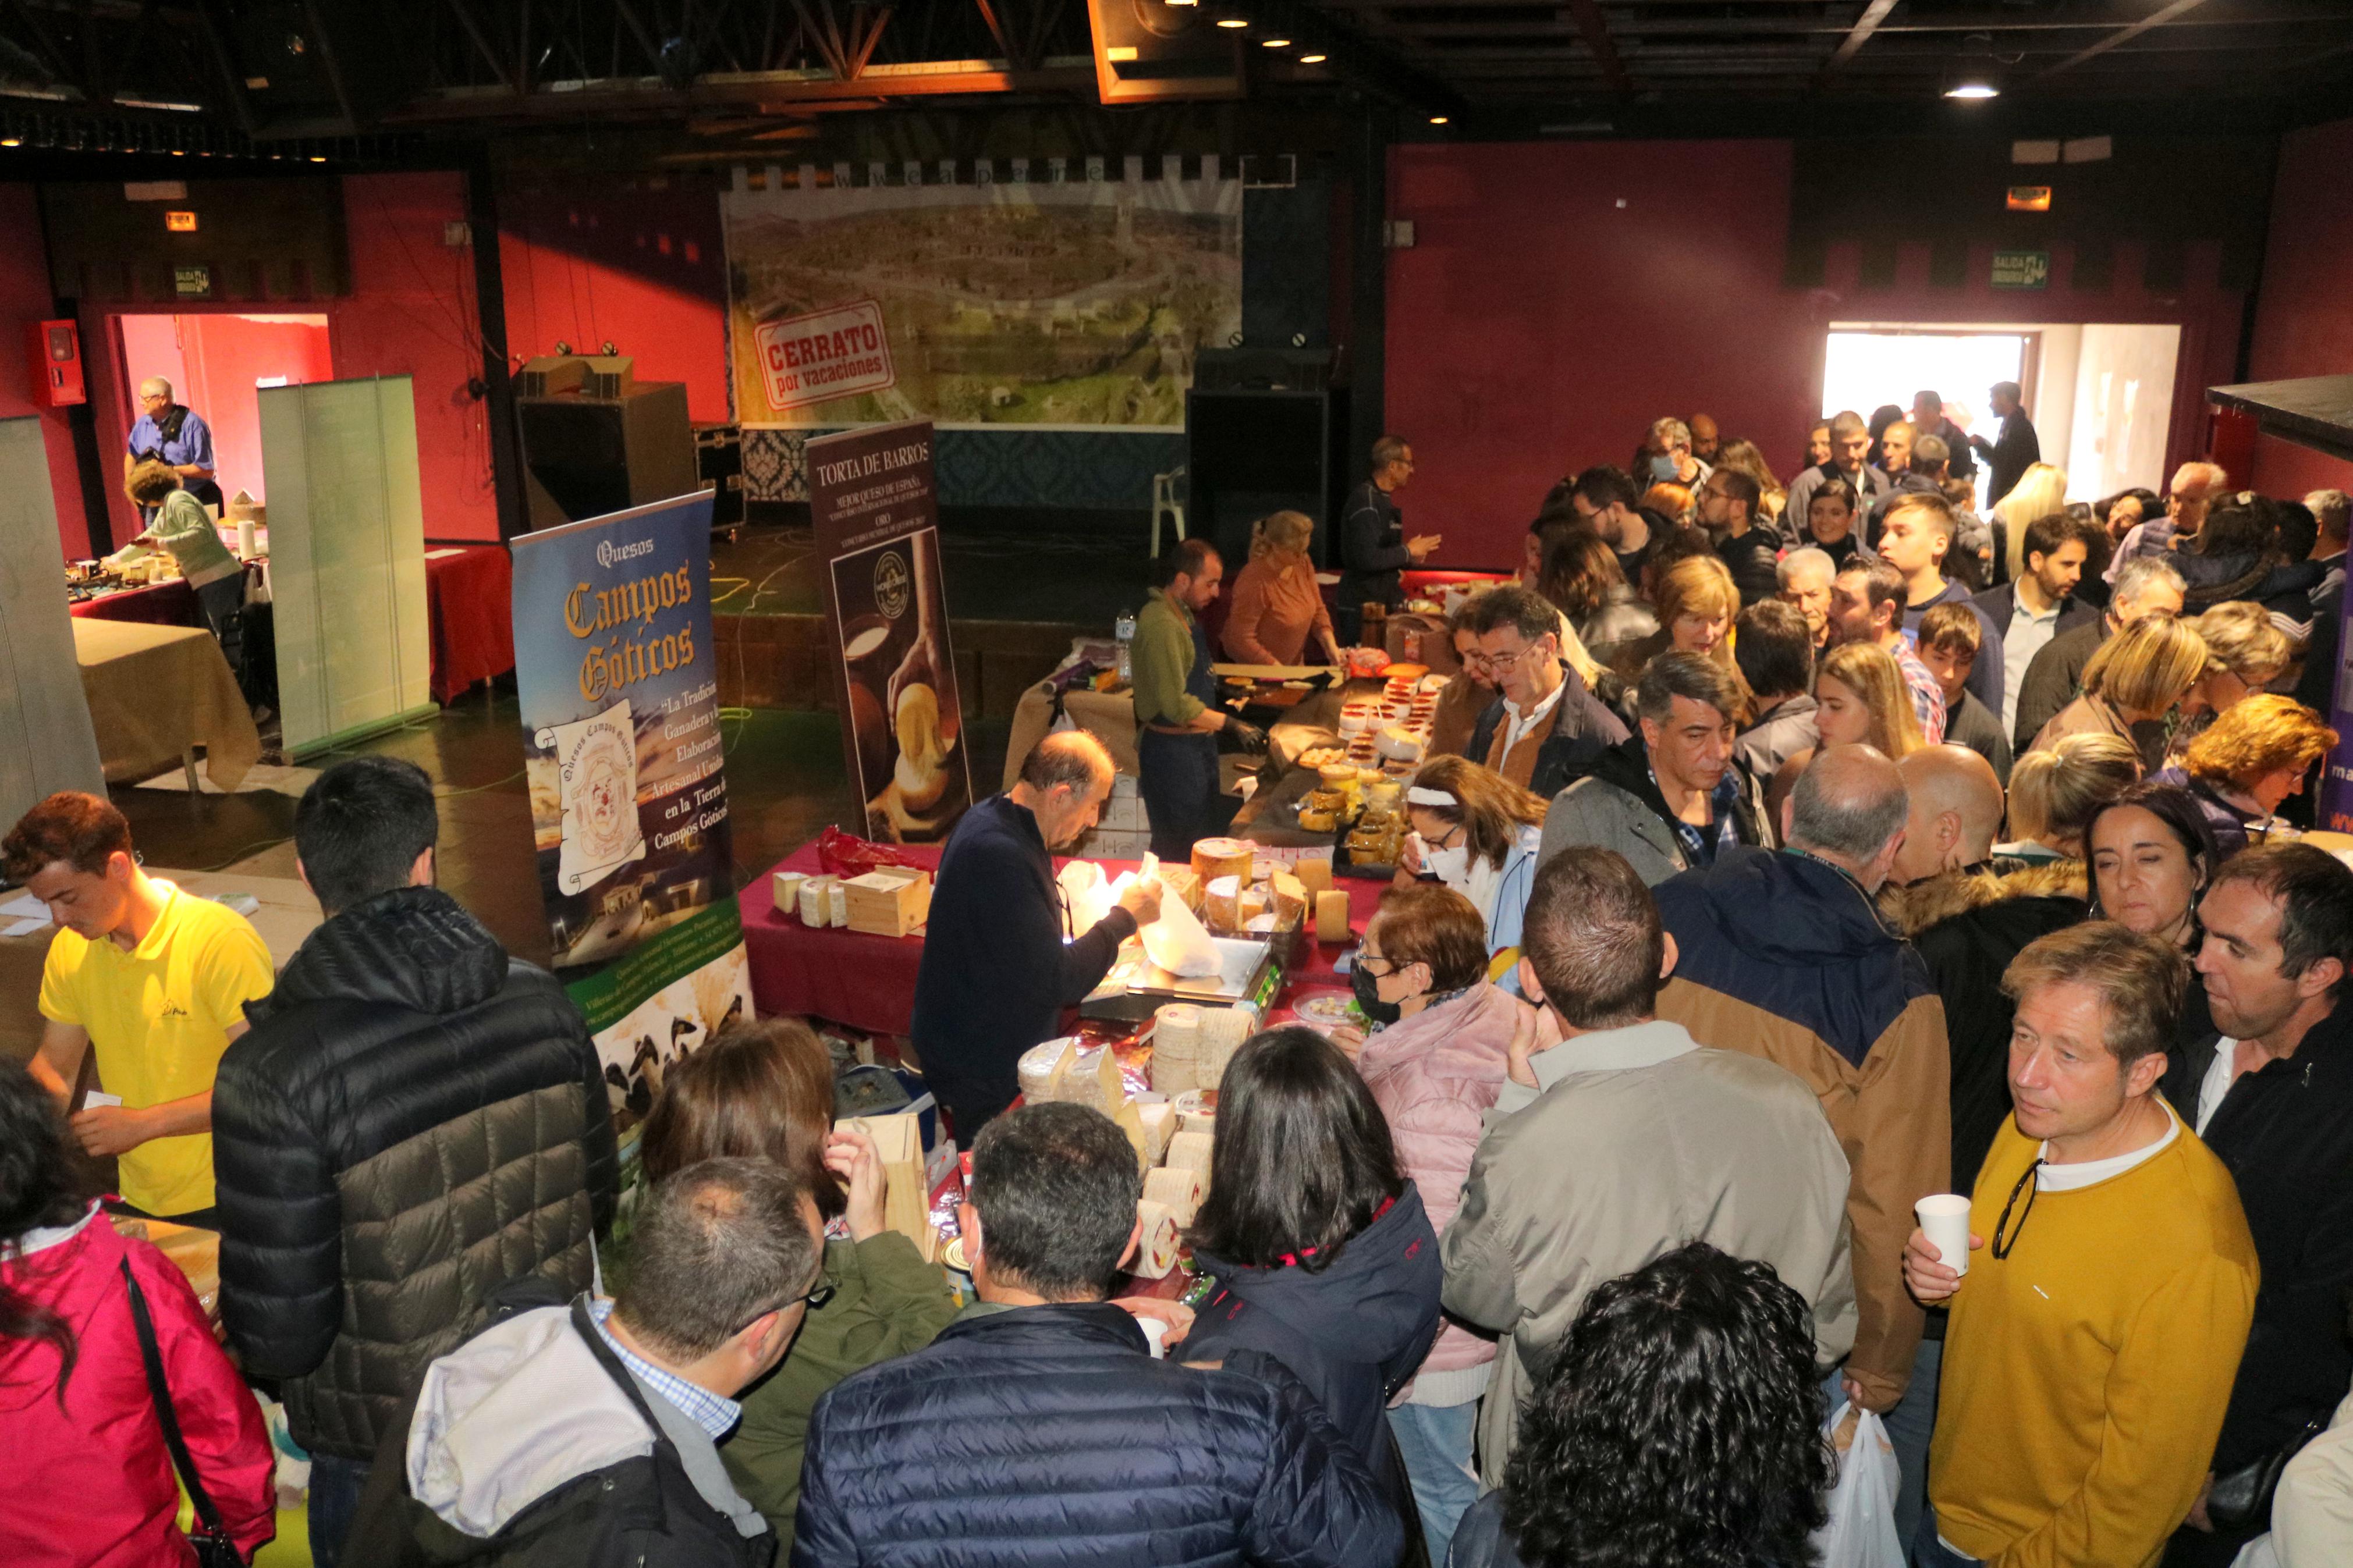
(2247, 120, 2353, 496)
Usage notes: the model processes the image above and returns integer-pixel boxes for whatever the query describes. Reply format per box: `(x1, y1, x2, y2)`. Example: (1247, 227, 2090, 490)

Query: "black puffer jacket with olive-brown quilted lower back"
(212, 888, 616, 1460)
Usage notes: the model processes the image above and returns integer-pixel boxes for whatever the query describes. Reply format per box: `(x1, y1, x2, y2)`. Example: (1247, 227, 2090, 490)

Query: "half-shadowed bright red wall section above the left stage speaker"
(499, 176, 727, 423)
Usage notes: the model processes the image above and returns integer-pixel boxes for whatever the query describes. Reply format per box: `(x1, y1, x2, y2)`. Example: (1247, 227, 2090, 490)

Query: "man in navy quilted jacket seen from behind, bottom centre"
(793, 1103, 1405, 1568)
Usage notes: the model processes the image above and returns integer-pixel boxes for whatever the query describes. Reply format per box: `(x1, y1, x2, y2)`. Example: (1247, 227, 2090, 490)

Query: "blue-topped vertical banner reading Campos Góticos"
(513, 491, 751, 1130)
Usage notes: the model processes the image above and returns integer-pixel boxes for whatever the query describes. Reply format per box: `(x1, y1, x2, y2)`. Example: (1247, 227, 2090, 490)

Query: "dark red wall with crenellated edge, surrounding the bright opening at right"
(1386, 141, 2242, 567)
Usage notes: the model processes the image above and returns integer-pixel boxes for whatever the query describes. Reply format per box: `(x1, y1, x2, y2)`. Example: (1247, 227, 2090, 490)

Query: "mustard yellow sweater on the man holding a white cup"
(1929, 1105, 2256, 1568)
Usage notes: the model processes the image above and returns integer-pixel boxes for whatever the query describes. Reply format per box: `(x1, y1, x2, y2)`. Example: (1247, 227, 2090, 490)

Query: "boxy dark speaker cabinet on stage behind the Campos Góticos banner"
(515, 381, 699, 529)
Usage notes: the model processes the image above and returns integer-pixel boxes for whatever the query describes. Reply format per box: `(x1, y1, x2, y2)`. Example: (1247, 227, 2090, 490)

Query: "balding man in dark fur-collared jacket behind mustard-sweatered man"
(1880, 745, 2085, 1530)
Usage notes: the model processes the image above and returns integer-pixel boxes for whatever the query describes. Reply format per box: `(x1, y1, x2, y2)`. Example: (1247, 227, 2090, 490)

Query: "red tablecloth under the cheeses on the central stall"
(736, 841, 1388, 1037)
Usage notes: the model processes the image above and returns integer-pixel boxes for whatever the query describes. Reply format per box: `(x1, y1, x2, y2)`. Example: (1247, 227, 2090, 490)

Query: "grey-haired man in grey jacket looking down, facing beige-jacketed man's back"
(1536, 653, 1774, 886)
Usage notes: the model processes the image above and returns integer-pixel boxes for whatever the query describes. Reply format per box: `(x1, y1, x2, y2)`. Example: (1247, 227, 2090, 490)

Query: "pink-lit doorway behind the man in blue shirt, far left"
(113, 310, 334, 501)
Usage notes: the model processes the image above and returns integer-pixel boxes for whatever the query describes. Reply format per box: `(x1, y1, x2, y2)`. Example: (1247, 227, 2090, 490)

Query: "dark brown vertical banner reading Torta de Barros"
(810, 421, 972, 844)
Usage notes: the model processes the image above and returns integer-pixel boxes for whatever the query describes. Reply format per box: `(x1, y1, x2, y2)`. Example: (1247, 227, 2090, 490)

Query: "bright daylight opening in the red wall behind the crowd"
(1821, 322, 2181, 506)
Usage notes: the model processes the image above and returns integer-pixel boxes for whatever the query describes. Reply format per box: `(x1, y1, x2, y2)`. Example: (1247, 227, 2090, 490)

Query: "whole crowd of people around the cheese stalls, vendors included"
(13, 388, 2353, 1568)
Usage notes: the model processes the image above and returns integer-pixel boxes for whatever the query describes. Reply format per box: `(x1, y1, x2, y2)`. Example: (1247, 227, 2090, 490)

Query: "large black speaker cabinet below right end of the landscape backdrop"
(1184, 385, 1351, 571)
